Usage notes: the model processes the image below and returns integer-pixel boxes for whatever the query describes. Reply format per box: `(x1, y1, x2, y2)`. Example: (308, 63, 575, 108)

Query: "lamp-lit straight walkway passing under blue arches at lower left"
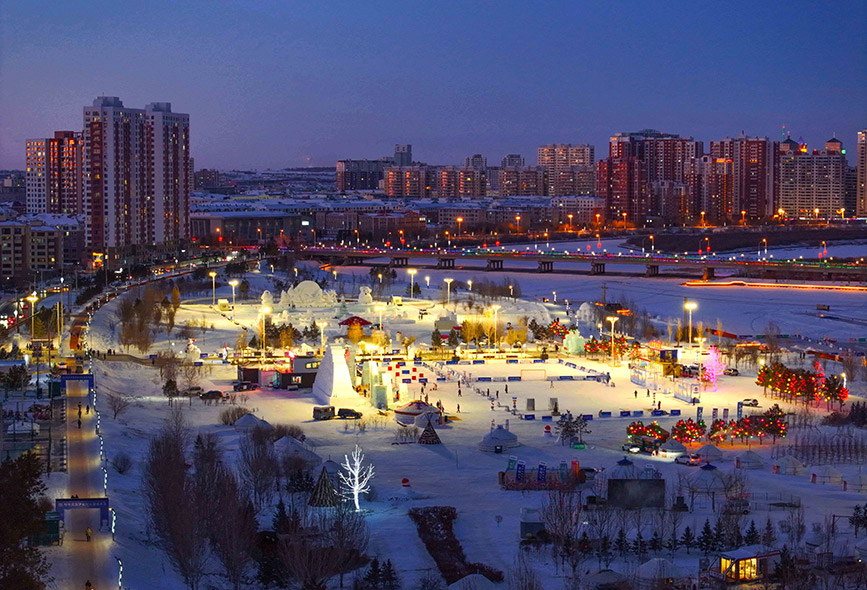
(63, 382, 117, 590)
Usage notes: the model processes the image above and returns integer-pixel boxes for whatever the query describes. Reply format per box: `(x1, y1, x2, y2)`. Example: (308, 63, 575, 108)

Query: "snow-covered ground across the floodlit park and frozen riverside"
(73, 268, 867, 590)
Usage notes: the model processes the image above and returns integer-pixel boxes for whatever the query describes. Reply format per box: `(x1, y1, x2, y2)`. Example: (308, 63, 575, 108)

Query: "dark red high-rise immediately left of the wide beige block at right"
(710, 135, 780, 219)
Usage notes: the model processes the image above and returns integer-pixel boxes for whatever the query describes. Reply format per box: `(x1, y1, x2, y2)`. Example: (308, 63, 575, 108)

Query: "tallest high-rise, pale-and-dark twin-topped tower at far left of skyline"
(84, 96, 191, 249)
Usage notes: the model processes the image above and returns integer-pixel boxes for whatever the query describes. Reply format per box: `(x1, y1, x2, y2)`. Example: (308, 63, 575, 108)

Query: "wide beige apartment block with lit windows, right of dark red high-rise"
(776, 139, 847, 219)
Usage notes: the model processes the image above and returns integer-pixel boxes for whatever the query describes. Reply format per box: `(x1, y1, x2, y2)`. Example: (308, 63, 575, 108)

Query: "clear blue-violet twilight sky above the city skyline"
(0, 0, 867, 169)
